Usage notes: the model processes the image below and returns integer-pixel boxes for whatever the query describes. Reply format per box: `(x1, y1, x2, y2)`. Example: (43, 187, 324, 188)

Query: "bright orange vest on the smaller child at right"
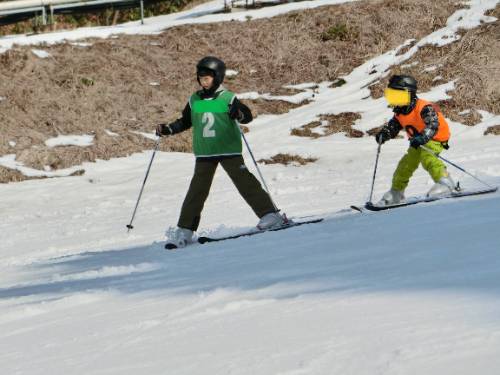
(395, 99, 450, 142)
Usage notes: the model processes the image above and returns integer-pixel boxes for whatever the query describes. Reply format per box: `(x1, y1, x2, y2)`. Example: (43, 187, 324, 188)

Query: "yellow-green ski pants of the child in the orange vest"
(392, 141, 448, 191)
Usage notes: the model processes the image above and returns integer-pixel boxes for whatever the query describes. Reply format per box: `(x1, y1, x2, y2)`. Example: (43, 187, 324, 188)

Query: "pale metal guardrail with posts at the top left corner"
(0, 0, 144, 25)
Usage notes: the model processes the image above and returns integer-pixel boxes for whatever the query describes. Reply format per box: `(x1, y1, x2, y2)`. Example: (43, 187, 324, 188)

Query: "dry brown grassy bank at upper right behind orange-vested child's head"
(370, 5, 500, 126)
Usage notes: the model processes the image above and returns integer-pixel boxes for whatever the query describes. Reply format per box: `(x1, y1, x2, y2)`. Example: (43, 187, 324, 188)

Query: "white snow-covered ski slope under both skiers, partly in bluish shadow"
(0, 0, 500, 375)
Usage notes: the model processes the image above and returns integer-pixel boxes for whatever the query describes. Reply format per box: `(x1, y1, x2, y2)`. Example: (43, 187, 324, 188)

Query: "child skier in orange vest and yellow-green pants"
(375, 75, 456, 206)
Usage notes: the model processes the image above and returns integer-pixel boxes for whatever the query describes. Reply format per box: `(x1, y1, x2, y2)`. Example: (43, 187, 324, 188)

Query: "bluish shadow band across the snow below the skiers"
(0, 195, 500, 299)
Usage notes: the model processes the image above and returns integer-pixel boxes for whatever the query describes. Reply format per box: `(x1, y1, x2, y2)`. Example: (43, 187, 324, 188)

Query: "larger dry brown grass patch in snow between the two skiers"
(290, 112, 363, 138)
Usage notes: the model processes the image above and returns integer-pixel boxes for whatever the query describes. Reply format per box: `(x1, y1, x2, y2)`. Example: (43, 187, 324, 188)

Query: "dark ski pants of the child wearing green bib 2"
(177, 155, 276, 231)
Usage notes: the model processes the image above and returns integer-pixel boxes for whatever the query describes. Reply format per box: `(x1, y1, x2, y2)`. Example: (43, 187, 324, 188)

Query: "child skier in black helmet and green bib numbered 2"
(156, 56, 286, 247)
